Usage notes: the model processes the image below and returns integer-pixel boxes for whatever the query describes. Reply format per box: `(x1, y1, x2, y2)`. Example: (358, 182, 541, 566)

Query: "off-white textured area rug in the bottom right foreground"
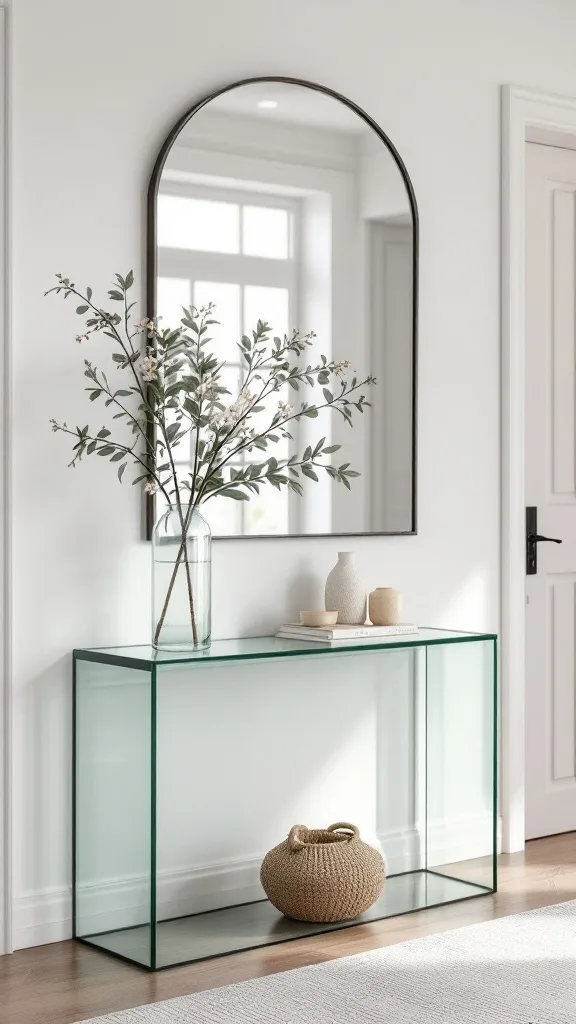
(78, 901, 576, 1024)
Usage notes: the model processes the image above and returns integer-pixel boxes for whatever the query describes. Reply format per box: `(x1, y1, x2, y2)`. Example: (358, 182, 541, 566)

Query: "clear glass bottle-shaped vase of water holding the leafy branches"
(152, 504, 212, 651)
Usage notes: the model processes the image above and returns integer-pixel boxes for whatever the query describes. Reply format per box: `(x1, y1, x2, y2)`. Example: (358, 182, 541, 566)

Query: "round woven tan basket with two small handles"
(260, 821, 386, 923)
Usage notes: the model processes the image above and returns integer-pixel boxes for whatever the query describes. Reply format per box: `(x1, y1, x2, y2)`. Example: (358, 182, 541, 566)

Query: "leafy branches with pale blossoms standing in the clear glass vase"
(46, 270, 375, 645)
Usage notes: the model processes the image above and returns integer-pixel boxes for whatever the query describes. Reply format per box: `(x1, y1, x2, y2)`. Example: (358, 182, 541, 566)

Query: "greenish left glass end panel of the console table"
(74, 660, 153, 967)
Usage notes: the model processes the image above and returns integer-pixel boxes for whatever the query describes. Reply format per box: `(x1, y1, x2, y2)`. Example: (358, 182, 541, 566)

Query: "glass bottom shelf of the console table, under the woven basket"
(80, 869, 494, 970)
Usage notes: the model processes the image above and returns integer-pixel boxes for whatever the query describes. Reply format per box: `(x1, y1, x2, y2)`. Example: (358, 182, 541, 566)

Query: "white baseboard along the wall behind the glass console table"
(13, 815, 500, 949)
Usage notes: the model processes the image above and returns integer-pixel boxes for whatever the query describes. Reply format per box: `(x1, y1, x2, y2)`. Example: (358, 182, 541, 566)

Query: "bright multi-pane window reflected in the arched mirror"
(157, 184, 299, 536)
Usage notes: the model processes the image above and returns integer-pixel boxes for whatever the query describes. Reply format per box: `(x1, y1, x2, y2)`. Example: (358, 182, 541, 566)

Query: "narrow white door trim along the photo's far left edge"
(0, 6, 12, 953)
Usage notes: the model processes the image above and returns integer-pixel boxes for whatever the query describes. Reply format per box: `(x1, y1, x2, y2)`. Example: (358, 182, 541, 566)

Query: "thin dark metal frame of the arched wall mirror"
(146, 75, 419, 541)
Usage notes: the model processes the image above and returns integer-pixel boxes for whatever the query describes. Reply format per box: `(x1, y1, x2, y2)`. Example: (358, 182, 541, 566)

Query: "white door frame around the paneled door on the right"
(501, 85, 576, 852)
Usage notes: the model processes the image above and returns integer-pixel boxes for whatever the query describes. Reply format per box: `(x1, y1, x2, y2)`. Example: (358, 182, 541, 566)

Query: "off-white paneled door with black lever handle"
(526, 143, 576, 839)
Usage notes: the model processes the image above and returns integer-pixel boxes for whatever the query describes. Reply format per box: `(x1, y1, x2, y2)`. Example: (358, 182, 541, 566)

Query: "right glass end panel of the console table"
(425, 640, 497, 888)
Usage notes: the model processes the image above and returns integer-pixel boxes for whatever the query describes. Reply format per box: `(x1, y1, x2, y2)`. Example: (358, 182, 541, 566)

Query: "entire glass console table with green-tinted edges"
(73, 629, 497, 971)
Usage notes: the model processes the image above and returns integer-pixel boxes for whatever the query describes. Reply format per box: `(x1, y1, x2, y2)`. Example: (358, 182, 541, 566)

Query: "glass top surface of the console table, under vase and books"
(74, 626, 497, 669)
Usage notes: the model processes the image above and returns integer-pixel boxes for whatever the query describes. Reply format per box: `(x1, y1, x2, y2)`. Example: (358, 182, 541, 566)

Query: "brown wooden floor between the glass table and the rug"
(0, 833, 576, 1024)
